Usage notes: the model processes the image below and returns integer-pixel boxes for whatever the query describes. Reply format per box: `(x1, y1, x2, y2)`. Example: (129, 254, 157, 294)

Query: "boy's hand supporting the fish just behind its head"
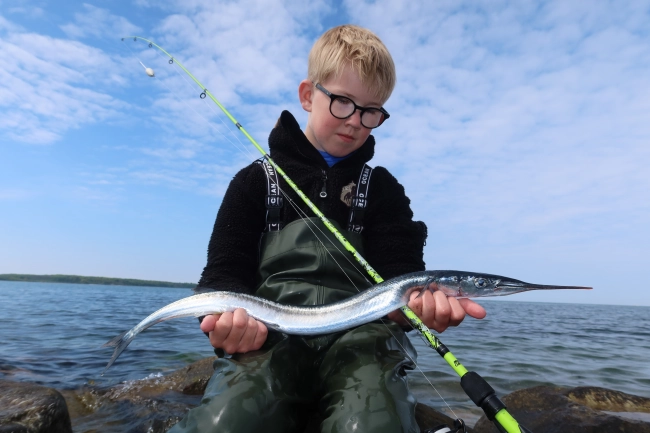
(388, 290, 487, 332)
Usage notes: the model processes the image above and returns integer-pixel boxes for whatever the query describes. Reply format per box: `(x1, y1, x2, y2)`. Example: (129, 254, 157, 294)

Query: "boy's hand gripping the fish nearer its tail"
(201, 308, 269, 353)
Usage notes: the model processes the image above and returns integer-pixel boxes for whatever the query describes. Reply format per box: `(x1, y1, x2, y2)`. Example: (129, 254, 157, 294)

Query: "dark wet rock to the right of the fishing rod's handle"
(474, 386, 650, 433)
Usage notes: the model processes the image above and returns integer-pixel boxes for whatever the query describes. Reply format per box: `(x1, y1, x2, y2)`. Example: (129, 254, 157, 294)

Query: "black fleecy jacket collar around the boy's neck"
(269, 110, 375, 168)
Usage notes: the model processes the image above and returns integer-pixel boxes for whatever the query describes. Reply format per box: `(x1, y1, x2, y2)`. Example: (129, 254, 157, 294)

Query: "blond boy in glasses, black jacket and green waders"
(171, 25, 485, 433)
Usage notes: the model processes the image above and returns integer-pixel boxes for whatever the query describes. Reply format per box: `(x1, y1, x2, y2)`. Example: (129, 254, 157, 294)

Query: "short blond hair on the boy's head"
(307, 24, 396, 102)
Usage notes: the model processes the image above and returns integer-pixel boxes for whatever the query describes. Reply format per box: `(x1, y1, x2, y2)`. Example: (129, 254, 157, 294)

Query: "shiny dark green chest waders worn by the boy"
(170, 174, 420, 433)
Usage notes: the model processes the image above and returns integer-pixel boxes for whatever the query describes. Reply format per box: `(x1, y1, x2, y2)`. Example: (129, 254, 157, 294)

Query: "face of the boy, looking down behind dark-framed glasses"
(298, 66, 384, 157)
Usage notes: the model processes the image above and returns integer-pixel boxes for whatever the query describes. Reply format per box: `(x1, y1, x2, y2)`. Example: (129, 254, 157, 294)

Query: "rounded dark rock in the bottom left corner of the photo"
(0, 380, 72, 433)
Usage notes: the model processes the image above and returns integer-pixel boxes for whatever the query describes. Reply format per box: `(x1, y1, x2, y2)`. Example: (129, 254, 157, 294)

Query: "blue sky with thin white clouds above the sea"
(0, 0, 650, 306)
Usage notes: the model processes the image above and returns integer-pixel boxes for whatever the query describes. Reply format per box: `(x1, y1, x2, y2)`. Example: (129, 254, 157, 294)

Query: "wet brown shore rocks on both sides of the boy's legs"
(0, 358, 650, 433)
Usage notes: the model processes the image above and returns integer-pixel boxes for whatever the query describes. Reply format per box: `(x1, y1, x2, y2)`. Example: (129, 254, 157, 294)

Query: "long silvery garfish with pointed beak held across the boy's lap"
(102, 271, 591, 374)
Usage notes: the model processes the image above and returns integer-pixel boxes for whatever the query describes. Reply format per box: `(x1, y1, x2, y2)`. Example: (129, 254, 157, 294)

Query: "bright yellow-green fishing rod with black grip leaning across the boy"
(122, 36, 531, 433)
